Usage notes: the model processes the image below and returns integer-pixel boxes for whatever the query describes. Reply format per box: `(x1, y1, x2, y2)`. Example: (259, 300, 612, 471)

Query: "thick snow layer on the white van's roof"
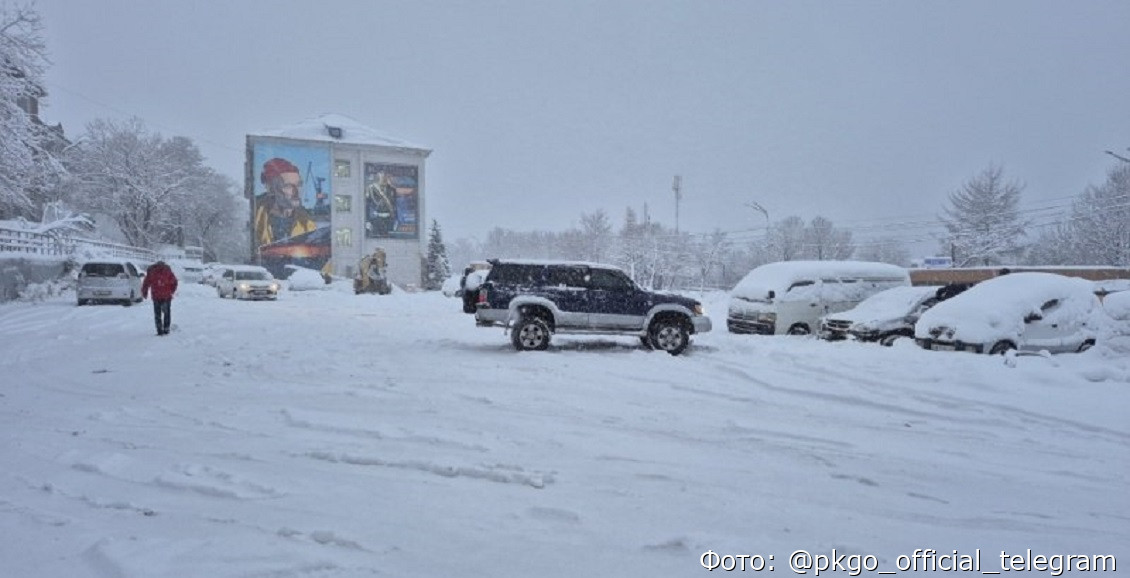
(732, 261, 910, 299)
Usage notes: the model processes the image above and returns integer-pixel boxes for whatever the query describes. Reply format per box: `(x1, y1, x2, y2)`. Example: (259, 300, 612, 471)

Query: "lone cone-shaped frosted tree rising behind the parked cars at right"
(942, 166, 1027, 266)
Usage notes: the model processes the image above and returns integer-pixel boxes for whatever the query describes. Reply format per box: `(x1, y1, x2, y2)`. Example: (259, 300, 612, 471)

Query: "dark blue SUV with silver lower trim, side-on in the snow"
(475, 260, 711, 356)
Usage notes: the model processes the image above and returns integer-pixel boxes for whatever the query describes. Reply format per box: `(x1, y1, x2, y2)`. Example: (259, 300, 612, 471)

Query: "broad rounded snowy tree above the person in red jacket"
(66, 119, 216, 247)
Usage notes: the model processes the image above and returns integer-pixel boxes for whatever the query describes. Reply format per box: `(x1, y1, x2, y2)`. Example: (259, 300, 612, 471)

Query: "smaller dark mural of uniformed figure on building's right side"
(365, 163, 419, 239)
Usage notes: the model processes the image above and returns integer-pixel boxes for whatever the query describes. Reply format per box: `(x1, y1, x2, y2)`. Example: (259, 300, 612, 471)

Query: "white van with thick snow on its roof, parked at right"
(725, 261, 911, 335)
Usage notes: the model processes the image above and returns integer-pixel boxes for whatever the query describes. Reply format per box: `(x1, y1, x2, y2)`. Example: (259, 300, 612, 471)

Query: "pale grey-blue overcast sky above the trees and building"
(30, 0, 1130, 250)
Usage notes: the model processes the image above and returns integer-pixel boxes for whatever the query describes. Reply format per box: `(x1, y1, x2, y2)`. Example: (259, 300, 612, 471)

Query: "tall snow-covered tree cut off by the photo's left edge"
(0, 5, 63, 219)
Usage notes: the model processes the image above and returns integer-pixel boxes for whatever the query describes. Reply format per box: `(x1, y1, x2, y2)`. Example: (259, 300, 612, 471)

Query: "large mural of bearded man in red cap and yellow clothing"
(249, 141, 332, 277)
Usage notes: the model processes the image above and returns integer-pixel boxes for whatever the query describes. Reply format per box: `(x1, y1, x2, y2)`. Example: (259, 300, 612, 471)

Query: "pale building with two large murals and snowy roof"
(245, 114, 432, 287)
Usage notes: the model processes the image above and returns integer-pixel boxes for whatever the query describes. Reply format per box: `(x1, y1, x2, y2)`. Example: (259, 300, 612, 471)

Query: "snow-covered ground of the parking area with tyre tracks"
(0, 282, 1130, 578)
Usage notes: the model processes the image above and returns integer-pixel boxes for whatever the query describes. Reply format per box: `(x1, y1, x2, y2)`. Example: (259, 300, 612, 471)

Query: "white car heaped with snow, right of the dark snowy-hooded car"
(914, 273, 1109, 354)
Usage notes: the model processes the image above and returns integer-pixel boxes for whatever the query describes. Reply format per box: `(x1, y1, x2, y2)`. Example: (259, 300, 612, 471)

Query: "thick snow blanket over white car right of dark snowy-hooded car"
(915, 273, 1098, 343)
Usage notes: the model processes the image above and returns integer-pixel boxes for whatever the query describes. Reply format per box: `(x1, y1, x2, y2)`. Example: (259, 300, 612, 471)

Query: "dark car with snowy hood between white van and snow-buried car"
(820, 286, 940, 345)
